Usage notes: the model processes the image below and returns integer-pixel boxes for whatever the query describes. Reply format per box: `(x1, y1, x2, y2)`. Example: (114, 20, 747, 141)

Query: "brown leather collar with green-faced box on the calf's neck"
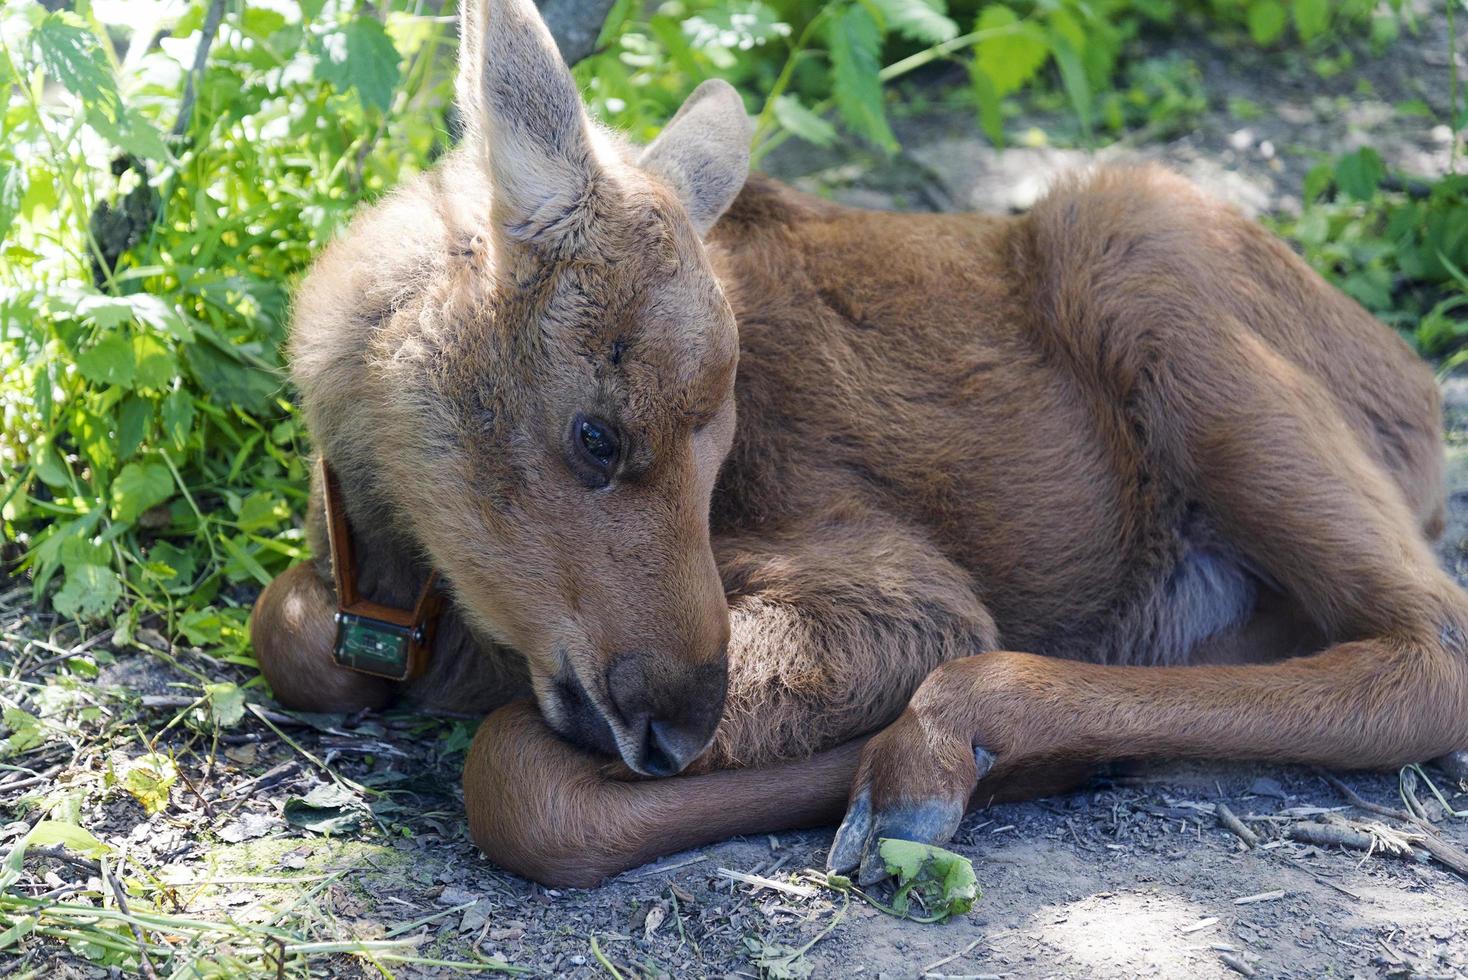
(320, 458, 442, 681)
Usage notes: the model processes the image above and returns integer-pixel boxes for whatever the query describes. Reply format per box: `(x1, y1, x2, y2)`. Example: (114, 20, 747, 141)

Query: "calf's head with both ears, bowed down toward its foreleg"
(372, 0, 750, 776)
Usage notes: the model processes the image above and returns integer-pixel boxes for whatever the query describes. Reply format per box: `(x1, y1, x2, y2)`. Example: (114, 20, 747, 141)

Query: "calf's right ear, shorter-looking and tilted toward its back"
(637, 79, 753, 235)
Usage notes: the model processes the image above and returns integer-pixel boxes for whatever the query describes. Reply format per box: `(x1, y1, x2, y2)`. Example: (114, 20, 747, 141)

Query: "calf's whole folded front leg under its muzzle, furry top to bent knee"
(464, 512, 995, 885)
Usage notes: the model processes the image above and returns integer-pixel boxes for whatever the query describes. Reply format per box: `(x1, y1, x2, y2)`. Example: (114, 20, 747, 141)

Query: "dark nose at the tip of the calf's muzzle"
(606, 645, 728, 776)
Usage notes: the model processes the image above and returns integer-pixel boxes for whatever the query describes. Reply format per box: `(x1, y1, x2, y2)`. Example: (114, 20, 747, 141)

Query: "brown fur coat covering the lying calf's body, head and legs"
(254, 0, 1468, 885)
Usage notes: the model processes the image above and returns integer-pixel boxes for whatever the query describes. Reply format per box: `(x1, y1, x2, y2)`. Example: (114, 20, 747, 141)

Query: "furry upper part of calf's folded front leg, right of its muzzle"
(699, 508, 998, 769)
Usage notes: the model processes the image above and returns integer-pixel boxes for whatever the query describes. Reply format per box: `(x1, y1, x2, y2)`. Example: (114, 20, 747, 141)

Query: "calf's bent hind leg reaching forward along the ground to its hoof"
(832, 311, 1468, 877)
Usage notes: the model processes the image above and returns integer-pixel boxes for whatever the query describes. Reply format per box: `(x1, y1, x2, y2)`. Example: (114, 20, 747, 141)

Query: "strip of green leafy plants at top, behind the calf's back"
(575, 0, 1402, 160)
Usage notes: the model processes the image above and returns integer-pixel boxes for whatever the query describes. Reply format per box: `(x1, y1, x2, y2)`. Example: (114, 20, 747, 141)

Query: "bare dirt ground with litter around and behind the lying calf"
(0, 13, 1468, 979)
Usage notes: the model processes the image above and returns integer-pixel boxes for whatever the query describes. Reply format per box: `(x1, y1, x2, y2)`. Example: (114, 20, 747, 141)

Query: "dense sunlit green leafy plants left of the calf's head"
(0, 0, 454, 651)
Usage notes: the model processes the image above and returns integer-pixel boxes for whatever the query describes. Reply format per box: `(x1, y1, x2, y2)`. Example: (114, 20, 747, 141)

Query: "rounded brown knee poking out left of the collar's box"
(250, 562, 398, 712)
